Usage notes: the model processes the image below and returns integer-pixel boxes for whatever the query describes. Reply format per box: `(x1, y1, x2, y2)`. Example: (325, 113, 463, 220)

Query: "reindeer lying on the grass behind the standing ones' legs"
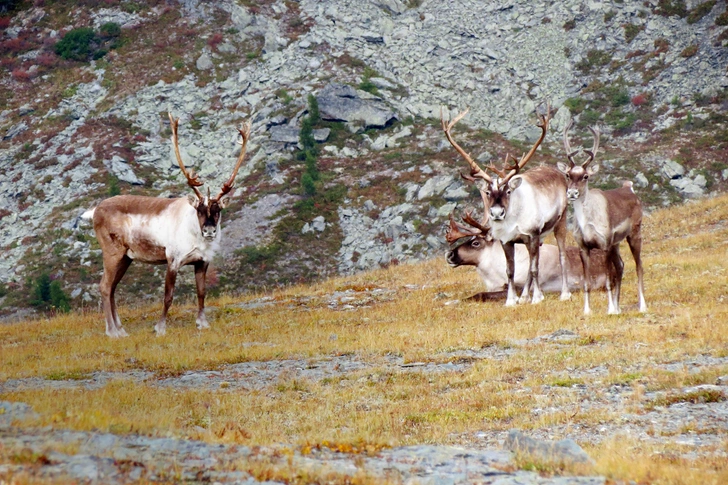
(445, 208, 607, 301)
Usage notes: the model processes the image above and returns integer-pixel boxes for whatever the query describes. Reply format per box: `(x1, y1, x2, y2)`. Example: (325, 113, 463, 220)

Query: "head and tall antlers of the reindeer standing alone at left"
(169, 113, 250, 239)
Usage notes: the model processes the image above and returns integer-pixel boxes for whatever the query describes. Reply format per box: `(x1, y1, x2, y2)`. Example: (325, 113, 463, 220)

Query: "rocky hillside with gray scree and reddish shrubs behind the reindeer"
(0, 0, 728, 315)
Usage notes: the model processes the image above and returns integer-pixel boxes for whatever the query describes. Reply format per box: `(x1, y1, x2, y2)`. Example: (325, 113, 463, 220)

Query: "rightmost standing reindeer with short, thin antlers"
(557, 120, 647, 315)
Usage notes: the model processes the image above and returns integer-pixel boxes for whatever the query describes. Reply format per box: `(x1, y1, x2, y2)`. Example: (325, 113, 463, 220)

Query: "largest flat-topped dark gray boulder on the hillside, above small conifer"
(316, 83, 396, 128)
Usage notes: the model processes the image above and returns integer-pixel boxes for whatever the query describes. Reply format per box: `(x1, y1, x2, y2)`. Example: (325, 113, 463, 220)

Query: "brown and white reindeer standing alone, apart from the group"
(81, 114, 250, 337)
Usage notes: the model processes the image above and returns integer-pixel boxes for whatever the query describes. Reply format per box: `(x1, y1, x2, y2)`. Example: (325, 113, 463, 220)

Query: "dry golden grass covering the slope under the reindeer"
(0, 196, 728, 484)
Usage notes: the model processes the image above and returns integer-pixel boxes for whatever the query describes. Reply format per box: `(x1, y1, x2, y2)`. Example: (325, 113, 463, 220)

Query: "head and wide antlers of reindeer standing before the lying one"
(440, 104, 551, 221)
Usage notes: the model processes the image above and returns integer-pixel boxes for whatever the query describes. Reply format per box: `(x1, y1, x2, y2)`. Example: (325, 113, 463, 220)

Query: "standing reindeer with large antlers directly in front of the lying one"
(441, 106, 571, 306)
